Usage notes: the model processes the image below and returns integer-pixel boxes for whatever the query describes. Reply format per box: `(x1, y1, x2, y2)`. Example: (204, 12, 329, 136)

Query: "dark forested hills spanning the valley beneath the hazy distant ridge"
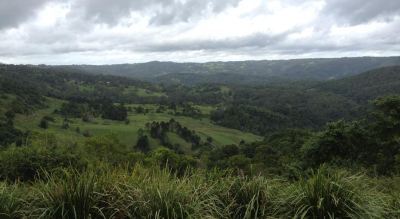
(0, 65, 400, 135)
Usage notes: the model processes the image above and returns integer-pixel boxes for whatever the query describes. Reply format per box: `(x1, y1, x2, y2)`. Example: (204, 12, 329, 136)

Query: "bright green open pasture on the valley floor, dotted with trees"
(15, 98, 261, 150)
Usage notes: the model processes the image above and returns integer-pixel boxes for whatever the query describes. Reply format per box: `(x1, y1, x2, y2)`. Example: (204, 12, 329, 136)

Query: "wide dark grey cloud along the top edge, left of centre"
(74, 0, 241, 25)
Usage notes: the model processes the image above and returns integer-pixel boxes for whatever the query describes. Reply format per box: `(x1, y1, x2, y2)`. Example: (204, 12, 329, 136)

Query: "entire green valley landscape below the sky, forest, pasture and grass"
(0, 62, 400, 219)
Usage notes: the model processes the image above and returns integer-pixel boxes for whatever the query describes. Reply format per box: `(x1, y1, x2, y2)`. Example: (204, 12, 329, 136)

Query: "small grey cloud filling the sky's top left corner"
(0, 0, 48, 29)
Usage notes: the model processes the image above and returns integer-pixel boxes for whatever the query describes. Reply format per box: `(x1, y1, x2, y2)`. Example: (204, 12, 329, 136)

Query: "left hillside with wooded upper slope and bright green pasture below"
(0, 65, 261, 152)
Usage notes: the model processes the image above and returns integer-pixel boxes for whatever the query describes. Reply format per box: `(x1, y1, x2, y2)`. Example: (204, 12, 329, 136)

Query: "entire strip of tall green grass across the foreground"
(0, 165, 400, 219)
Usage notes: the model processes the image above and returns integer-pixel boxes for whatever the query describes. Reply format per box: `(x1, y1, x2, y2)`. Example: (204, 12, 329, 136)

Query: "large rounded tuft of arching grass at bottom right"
(283, 167, 384, 218)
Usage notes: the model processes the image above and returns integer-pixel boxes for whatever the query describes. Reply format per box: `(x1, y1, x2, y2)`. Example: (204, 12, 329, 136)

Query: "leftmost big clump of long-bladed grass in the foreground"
(33, 170, 101, 219)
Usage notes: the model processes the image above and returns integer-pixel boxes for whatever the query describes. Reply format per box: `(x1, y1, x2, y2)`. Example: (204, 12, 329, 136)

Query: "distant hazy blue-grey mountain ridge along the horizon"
(54, 56, 400, 85)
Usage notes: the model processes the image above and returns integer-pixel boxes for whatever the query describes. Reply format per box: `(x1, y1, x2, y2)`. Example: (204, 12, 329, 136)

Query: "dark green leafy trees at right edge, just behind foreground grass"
(303, 96, 400, 174)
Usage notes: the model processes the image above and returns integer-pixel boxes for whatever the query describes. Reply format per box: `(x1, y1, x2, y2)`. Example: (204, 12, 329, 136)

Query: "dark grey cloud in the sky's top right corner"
(321, 0, 400, 25)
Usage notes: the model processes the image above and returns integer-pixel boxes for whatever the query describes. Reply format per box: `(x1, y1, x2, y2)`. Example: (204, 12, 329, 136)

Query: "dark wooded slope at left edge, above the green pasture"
(0, 65, 164, 106)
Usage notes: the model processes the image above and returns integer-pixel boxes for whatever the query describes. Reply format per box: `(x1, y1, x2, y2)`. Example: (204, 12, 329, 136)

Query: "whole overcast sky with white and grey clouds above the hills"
(0, 0, 400, 64)
